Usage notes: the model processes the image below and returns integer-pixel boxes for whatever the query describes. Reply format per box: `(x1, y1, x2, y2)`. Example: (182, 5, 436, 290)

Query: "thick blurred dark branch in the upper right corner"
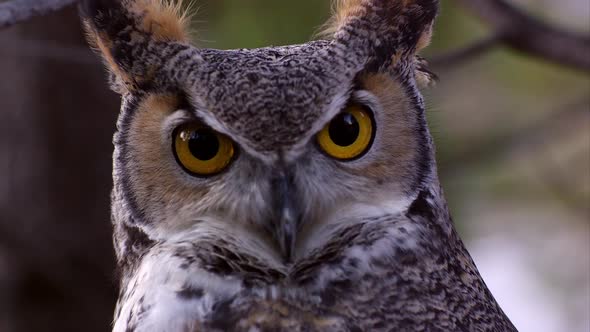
(457, 0, 590, 72)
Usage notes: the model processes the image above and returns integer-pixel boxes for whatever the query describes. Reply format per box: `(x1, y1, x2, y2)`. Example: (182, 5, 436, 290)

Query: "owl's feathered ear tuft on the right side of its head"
(319, 0, 438, 77)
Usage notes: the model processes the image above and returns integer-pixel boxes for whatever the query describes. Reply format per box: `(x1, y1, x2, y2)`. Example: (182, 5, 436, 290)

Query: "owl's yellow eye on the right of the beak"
(317, 105, 375, 160)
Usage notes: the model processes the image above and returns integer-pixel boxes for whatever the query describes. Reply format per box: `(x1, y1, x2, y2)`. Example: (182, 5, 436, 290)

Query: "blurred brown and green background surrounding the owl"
(0, 0, 590, 332)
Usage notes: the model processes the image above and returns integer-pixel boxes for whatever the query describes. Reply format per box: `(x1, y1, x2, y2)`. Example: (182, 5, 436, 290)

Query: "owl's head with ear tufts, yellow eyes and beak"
(81, 0, 438, 260)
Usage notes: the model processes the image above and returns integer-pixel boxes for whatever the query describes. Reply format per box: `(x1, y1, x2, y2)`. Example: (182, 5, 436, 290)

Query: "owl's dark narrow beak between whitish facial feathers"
(269, 169, 301, 262)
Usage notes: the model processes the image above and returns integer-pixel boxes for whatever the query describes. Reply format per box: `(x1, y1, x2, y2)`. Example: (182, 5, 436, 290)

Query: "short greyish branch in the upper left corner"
(0, 0, 78, 29)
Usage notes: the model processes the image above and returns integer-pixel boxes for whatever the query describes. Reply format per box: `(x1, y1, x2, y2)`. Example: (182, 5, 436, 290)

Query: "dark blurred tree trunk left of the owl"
(0, 7, 118, 331)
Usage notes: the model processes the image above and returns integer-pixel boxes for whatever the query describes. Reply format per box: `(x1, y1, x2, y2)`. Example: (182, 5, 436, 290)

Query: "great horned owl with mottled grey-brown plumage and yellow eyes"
(81, 0, 515, 331)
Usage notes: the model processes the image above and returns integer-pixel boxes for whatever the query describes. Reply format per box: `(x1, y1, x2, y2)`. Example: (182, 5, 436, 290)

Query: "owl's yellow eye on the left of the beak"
(173, 124, 234, 176)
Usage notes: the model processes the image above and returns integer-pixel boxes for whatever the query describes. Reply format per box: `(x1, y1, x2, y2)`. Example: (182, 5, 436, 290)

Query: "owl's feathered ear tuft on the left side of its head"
(79, 0, 190, 93)
